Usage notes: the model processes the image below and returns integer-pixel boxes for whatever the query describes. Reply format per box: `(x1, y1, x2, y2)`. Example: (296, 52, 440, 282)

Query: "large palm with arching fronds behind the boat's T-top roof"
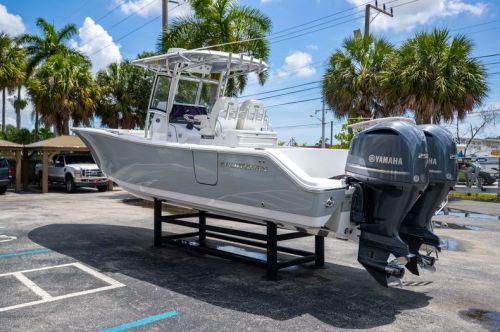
(158, 0, 272, 95)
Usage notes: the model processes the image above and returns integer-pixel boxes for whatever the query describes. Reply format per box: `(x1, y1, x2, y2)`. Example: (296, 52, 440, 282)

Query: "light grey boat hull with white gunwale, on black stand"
(76, 129, 352, 237)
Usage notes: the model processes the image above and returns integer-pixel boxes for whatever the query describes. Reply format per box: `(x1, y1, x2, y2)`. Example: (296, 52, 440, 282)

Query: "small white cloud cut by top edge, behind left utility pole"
(115, 0, 191, 17)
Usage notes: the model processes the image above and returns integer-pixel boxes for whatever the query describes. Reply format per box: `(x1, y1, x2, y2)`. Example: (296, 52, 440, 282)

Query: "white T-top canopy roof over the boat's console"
(132, 48, 268, 74)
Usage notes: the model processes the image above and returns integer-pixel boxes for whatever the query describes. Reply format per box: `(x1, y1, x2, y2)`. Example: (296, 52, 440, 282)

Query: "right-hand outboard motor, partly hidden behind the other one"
(399, 125, 457, 275)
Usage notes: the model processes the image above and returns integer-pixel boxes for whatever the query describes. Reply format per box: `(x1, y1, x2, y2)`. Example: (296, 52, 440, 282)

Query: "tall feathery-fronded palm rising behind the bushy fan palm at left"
(20, 18, 81, 140)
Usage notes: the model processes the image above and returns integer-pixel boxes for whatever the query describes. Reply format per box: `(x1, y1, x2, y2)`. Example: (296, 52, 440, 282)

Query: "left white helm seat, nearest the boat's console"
(200, 97, 238, 136)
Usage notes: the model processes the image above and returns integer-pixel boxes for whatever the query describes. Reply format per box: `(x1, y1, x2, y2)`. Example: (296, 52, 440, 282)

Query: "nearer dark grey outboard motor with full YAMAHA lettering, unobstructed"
(346, 121, 428, 287)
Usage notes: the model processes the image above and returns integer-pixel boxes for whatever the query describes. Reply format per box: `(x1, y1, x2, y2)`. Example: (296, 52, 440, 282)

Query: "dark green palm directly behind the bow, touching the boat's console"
(96, 61, 152, 129)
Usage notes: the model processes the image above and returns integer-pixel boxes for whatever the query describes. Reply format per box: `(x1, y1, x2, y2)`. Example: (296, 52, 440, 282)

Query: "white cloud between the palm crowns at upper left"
(72, 17, 122, 74)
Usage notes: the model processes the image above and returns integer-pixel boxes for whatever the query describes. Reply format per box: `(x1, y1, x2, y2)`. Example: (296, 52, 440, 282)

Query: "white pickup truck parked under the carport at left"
(35, 154, 108, 192)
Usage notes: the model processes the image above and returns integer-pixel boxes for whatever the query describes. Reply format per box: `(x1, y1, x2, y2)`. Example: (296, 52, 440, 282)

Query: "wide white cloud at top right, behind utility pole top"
(348, 0, 487, 31)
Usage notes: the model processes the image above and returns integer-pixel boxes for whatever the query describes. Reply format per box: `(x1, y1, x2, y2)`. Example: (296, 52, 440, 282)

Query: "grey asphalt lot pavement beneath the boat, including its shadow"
(0, 189, 500, 332)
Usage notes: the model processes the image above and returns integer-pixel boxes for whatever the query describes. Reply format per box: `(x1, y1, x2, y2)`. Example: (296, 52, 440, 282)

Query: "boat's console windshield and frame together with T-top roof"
(133, 49, 268, 138)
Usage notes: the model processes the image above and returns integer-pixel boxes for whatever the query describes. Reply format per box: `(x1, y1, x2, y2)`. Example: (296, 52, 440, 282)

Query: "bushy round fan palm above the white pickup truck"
(28, 53, 99, 135)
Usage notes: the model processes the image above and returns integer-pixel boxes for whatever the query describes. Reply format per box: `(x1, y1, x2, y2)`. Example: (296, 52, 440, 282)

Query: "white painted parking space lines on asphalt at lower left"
(0, 263, 125, 312)
